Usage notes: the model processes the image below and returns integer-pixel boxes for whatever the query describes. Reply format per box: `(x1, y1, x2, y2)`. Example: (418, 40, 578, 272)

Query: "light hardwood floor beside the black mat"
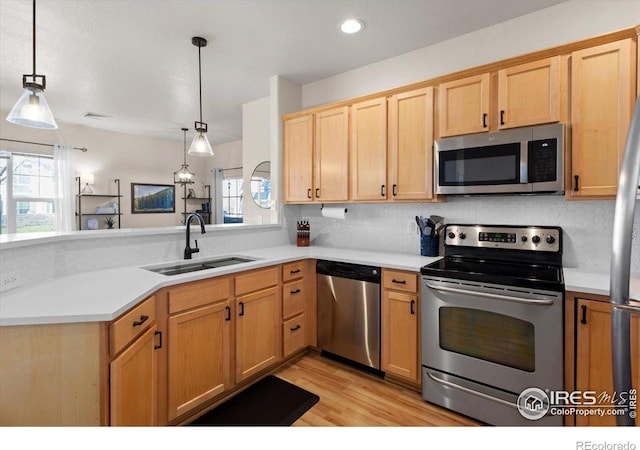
(275, 352, 481, 427)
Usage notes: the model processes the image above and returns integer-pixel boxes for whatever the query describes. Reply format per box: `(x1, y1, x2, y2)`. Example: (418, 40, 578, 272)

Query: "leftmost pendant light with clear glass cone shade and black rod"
(7, 0, 58, 130)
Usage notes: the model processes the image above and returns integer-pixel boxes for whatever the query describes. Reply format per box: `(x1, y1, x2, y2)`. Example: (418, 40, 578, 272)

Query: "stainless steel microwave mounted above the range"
(434, 124, 565, 194)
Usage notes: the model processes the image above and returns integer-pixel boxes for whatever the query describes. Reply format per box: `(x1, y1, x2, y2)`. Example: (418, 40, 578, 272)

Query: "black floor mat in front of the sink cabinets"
(187, 375, 320, 427)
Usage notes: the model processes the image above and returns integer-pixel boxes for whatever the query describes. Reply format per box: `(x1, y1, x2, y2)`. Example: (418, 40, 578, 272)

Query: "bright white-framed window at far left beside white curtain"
(0, 151, 56, 234)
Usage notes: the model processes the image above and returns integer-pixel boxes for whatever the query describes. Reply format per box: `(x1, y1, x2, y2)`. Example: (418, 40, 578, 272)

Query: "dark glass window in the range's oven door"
(439, 307, 536, 372)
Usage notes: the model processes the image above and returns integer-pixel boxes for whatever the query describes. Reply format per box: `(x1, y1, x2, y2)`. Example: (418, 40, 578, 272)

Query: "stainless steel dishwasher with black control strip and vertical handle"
(316, 260, 381, 370)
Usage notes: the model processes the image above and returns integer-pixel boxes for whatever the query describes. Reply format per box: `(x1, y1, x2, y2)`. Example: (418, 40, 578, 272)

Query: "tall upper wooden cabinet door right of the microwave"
(568, 39, 636, 197)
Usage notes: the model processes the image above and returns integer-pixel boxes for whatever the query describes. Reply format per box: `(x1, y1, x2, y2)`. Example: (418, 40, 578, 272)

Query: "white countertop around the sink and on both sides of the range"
(0, 245, 640, 326)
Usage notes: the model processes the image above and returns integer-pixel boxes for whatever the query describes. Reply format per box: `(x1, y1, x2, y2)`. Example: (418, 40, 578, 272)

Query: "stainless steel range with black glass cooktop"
(421, 225, 564, 426)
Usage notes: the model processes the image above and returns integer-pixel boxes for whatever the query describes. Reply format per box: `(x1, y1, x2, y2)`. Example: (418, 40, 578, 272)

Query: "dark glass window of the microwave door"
(439, 143, 520, 186)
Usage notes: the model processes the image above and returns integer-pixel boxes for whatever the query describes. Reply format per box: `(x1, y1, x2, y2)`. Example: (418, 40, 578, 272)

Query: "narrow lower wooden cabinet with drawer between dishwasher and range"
(381, 269, 420, 383)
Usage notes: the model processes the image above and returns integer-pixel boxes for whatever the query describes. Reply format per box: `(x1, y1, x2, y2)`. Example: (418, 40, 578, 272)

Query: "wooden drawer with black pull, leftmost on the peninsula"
(109, 295, 156, 356)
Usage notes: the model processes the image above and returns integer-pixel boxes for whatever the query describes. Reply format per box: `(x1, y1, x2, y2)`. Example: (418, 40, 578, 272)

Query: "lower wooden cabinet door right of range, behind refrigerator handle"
(576, 299, 640, 426)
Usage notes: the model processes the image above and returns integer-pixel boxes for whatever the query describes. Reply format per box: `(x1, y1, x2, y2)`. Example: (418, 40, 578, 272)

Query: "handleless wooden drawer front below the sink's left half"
(169, 277, 231, 314)
